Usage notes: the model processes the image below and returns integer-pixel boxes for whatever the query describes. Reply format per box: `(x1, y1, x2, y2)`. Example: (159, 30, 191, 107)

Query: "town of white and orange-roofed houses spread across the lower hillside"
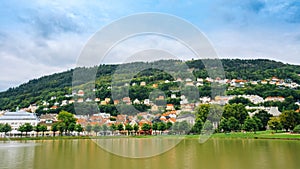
(0, 77, 300, 137)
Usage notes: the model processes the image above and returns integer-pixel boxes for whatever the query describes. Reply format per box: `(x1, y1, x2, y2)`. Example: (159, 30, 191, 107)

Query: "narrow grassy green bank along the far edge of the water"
(0, 131, 300, 141)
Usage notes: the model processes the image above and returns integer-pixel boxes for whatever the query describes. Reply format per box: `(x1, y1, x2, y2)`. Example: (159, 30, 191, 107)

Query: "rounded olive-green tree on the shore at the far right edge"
(279, 110, 300, 131)
